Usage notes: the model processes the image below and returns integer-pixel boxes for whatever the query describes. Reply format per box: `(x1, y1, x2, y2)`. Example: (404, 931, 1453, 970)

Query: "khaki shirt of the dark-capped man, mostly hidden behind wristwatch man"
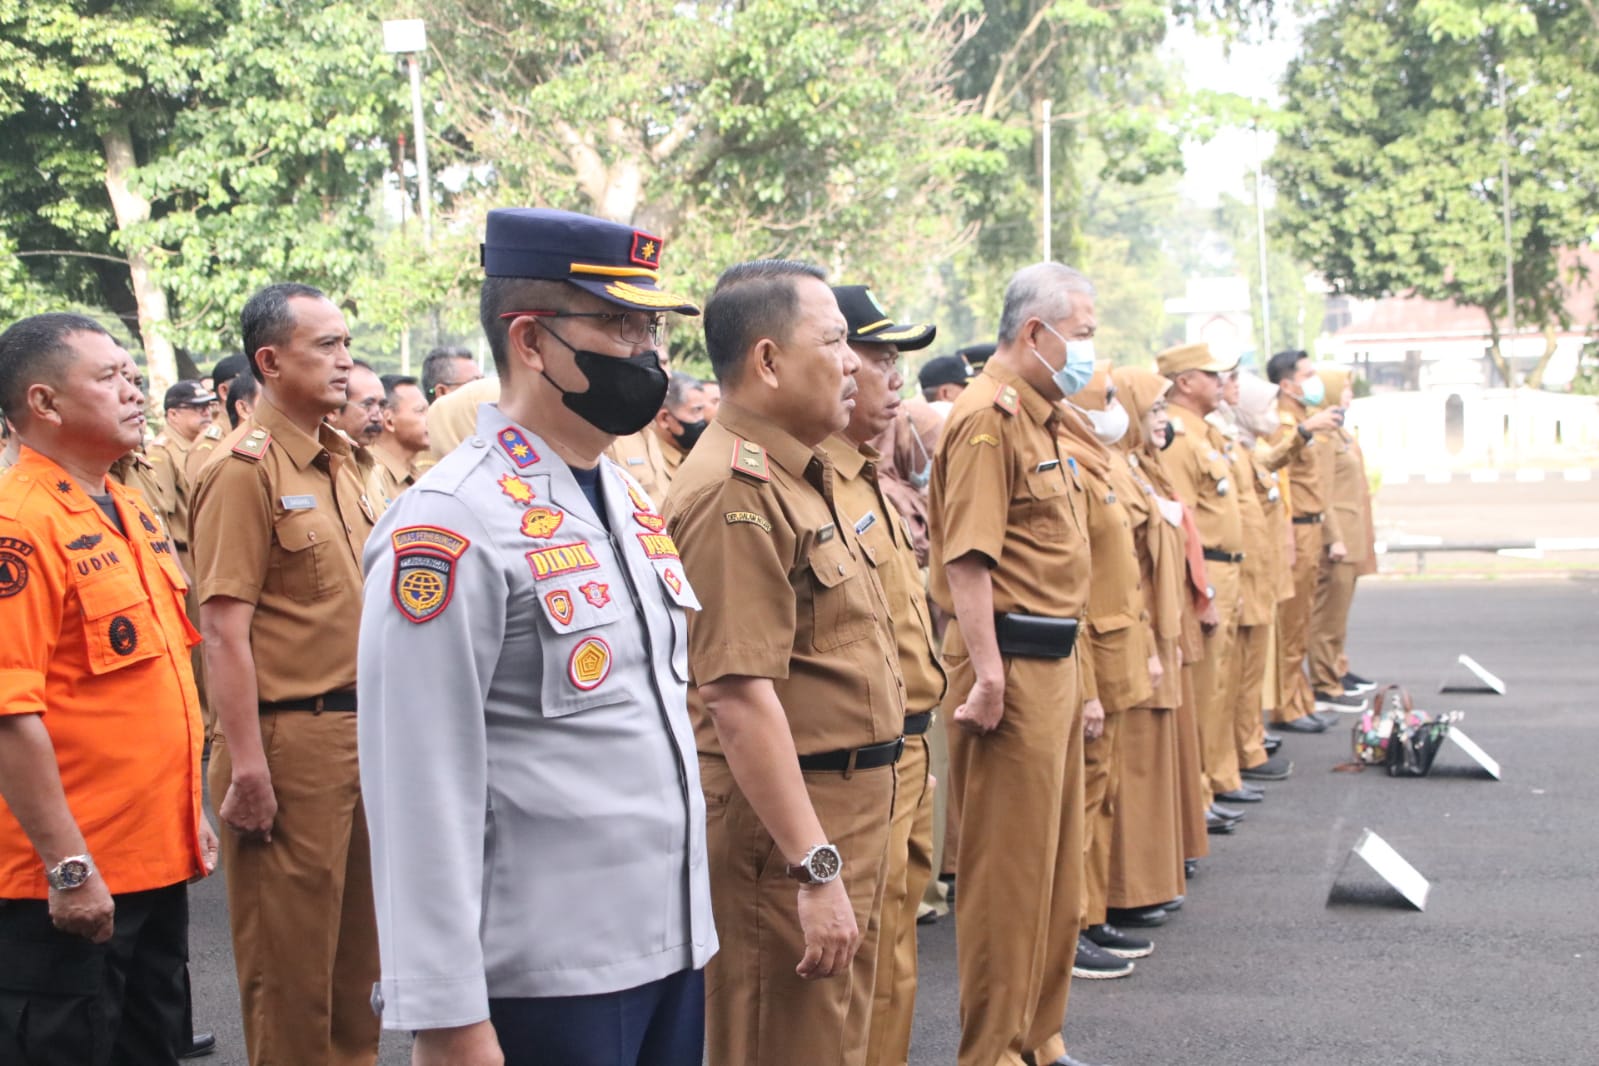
(822, 435, 945, 714)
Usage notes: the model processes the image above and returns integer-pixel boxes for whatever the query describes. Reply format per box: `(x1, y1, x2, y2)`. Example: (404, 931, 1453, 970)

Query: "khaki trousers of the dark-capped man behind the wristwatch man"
(867, 730, 932, 1066)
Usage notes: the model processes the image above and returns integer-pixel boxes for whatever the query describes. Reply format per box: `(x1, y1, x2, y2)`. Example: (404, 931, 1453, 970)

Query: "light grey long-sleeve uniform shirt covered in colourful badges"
(358, 404, 716, 1029)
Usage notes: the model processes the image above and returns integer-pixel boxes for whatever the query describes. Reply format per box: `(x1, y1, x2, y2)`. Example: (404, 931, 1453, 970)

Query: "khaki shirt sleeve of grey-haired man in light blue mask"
(939, 408, 1017, 566)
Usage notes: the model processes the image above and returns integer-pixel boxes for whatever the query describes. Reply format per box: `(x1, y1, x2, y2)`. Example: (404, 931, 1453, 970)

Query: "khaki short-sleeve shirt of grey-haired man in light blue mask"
(929, 363, 1089, 620)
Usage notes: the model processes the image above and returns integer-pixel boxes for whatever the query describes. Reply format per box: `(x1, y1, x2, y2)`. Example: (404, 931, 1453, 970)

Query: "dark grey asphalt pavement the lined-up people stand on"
(190, 577, 1599, 1066)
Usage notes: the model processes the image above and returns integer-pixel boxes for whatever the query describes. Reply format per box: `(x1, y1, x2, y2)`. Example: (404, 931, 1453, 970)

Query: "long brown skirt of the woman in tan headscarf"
(1105, 706, 1186, 909)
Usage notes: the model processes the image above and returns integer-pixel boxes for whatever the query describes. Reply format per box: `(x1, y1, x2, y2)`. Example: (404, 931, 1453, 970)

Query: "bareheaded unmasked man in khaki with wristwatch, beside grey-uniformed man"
(665, 261, 905, 1066)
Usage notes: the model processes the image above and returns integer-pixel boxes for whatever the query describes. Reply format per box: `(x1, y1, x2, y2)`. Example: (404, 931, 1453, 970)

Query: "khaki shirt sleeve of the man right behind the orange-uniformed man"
(189, 457, 272, 604)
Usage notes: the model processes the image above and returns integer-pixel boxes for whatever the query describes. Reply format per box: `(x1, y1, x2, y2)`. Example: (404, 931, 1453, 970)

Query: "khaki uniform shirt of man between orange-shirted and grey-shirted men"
(193, 398, 376, 703)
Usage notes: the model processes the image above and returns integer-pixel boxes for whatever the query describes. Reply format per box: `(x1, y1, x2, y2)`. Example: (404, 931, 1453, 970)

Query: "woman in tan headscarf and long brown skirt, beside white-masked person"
(1107, 366, 1209, 911)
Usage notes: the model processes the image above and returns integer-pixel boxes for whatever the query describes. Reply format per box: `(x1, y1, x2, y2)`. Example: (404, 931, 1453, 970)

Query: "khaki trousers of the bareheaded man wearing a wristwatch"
(699, 754, 894, 1066)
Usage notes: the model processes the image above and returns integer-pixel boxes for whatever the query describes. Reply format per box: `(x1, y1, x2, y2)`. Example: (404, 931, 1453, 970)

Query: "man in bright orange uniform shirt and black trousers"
(0, 315, 216, 1066)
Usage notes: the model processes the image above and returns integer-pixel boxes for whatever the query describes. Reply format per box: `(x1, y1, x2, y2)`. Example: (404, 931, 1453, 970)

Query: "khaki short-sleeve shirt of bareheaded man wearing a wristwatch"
(662, 400, 905, 754)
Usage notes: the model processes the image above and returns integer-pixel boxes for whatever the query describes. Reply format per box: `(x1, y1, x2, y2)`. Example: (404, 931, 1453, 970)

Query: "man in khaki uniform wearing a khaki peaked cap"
(1158, 344, 1265, 811)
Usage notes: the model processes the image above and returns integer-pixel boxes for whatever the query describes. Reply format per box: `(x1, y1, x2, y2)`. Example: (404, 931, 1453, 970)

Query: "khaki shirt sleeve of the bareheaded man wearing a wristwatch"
(667, 476, 795, 684)
